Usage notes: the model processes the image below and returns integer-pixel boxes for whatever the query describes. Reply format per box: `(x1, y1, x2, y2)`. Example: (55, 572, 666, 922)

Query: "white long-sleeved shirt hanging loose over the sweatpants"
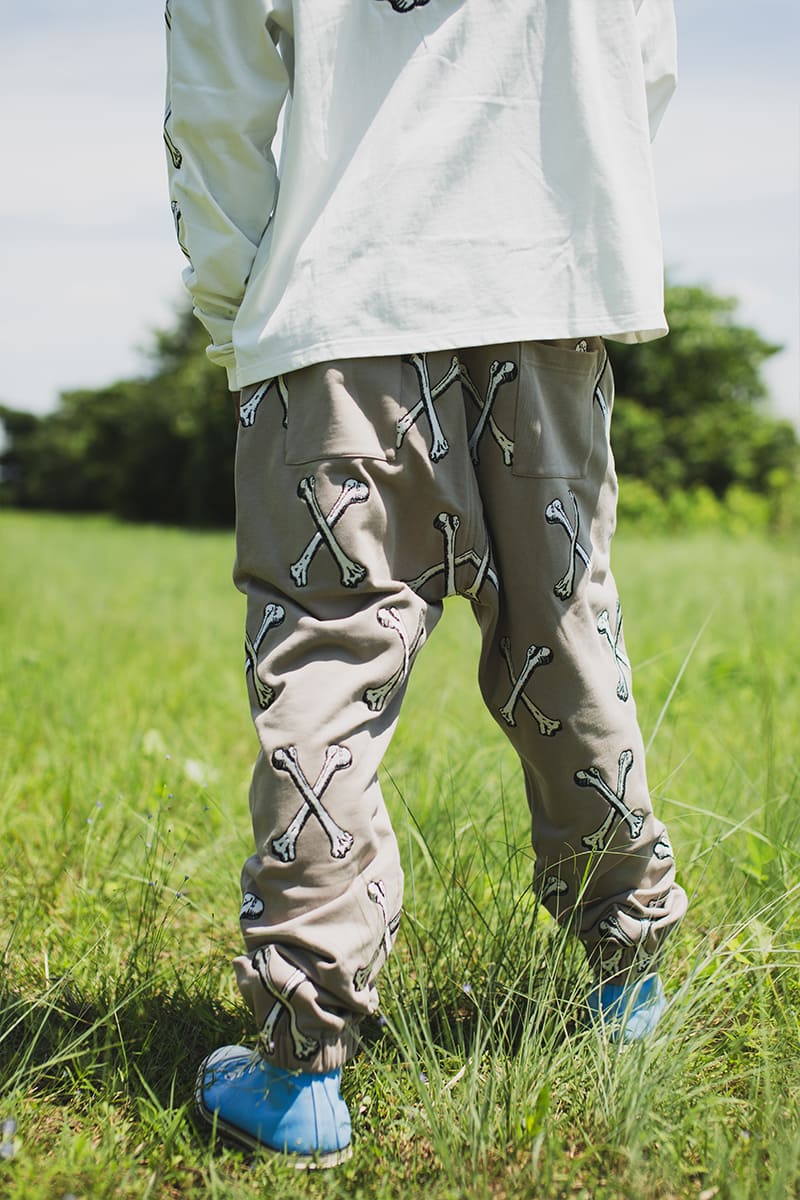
(164, 0, 675, 389)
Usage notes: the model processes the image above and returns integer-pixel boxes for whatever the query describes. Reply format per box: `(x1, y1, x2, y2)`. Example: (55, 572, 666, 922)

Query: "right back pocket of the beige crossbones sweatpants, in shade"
(511, 337, 602, 479)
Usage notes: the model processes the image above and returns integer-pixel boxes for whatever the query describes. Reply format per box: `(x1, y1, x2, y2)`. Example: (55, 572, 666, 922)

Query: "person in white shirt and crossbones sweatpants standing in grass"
(164, 0, 686, 1165)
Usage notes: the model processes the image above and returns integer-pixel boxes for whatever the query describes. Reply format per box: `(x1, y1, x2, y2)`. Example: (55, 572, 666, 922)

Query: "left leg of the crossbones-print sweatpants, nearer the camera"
(227, 355, 477, 1072)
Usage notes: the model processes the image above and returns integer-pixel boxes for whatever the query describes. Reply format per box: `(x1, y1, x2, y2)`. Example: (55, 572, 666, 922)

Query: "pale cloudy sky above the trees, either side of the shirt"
(0, 0, 800, 427)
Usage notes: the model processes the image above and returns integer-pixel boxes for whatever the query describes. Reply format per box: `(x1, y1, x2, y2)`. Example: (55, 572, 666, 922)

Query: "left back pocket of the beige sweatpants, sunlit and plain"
(285, 358, 401, 466)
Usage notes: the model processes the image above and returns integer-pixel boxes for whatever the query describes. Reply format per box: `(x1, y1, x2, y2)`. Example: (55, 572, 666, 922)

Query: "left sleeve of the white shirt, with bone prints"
(164, 0, 289, 367)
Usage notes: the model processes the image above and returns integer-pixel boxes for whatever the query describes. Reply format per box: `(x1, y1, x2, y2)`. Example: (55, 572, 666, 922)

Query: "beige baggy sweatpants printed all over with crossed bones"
(235, 338, 686, 1072)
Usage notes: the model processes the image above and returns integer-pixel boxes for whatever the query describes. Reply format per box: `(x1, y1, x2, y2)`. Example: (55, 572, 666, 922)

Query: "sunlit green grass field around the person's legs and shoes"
(0, 512, 800, 1200)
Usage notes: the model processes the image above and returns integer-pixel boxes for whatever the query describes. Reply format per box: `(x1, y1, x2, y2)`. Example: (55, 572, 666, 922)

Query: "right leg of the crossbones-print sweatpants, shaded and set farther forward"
(462, 338, 686, 978)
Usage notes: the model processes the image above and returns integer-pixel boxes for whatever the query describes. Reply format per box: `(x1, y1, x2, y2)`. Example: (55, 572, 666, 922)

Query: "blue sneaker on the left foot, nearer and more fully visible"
(194, 1046, 353, 1169)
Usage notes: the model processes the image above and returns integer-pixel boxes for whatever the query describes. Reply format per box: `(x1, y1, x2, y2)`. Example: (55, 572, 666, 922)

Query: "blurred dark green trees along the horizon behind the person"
(0, 287, 800, 527)
